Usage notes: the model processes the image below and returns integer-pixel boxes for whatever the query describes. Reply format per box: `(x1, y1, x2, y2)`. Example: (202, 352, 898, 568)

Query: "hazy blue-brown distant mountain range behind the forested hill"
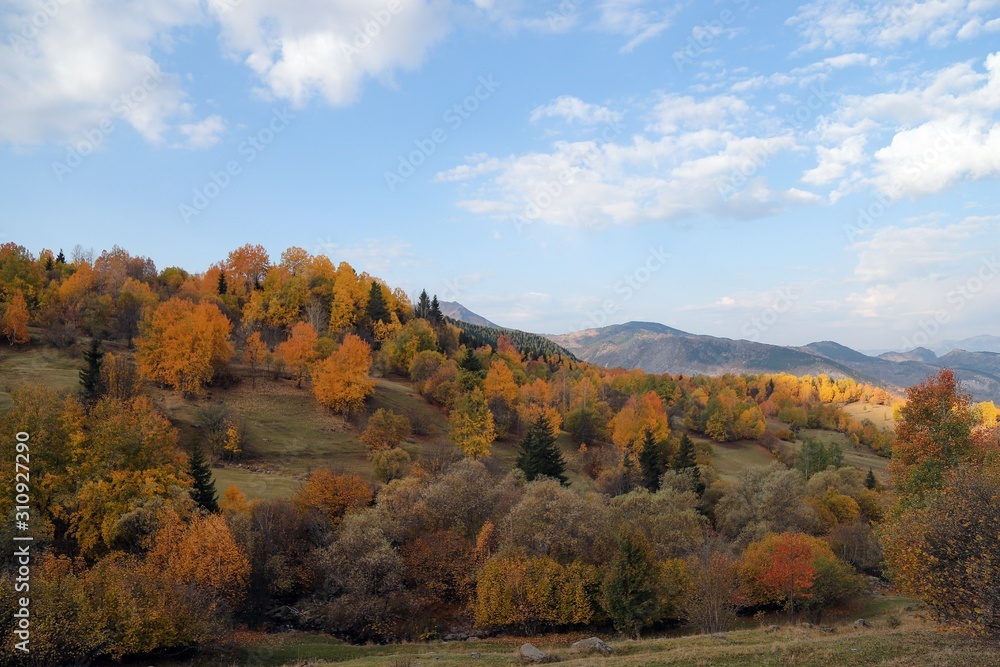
(442, 304, 1000, 402)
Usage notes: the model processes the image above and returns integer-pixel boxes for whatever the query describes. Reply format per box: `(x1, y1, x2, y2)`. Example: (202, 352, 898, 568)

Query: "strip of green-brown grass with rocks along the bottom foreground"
(163, 597, 1000, 667)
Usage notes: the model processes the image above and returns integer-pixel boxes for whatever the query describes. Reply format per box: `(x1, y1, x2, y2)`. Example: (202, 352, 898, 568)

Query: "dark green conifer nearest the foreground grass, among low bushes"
(604, 534, 660, 639)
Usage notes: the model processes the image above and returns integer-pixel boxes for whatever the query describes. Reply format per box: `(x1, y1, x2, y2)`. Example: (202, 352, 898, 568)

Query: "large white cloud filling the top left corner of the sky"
(0, 0, 204, 144)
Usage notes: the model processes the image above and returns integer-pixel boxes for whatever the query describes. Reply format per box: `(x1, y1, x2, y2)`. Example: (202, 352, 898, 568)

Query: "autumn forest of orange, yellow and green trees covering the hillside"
(0, 242, 1000, 665)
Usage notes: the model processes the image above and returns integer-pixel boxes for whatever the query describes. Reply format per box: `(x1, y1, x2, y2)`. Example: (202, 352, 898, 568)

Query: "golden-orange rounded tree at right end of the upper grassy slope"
(312, 334, 375, 414)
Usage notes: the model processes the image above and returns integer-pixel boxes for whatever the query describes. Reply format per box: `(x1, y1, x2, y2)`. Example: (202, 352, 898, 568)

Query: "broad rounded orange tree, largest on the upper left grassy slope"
(136, 298, 232, 394)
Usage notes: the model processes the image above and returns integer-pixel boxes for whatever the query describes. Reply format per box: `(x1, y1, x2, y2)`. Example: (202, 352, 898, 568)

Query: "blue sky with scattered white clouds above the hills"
(0, 0, 1000, 350)
